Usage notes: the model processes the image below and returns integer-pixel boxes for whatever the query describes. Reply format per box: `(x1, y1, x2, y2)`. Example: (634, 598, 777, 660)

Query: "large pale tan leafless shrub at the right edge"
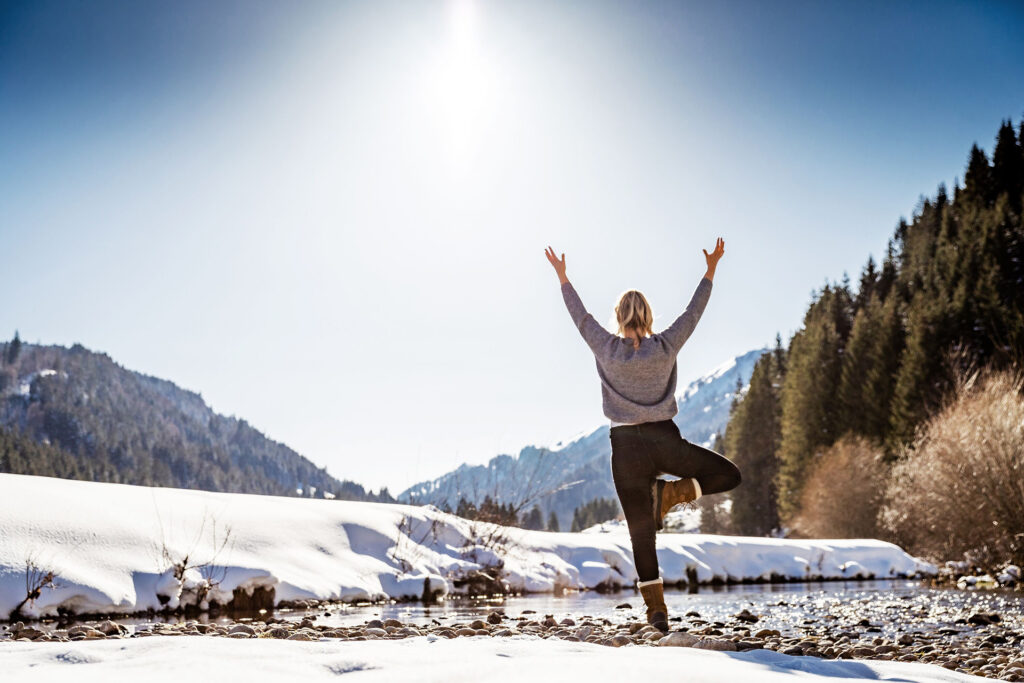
(882, 371, 1024, 567)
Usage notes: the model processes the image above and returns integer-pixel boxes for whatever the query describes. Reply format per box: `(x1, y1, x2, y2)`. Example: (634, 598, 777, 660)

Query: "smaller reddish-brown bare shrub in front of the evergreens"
(792, 435, 889, 539)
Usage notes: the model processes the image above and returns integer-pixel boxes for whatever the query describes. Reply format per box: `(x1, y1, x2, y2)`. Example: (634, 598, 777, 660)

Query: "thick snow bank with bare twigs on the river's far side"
(0, 474, 936, 618)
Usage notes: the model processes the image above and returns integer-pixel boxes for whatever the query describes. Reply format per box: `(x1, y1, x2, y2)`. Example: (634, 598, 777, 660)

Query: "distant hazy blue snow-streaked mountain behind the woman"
(398, 348, 767, 530)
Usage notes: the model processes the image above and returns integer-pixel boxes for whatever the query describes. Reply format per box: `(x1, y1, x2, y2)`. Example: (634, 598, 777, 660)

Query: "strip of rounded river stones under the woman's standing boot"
(6, 594, 1024, 681)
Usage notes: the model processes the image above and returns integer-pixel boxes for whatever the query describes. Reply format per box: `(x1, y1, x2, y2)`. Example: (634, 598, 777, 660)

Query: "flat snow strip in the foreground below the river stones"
(0, 636, 986, 683)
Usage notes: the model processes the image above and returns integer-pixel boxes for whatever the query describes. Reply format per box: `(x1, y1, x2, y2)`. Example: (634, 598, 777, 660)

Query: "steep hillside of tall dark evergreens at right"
(725, 121, 1024, 535)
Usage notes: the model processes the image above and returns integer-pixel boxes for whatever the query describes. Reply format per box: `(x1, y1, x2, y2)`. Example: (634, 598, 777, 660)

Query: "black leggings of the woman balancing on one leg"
(610, 420, 739, 581)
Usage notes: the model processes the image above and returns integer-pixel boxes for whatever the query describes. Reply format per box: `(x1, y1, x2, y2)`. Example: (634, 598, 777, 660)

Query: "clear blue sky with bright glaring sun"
(0, 0, 1024, 492)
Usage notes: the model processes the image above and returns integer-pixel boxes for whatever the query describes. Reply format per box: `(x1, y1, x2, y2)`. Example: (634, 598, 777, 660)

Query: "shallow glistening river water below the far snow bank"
(34, 580, 1024, 637)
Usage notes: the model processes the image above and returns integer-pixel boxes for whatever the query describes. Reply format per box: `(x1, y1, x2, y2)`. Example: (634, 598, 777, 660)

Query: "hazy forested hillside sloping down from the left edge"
(0, 342, 393, 502)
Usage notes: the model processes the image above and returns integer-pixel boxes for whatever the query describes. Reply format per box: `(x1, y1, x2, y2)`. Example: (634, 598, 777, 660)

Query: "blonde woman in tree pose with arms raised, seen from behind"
(545, 238, 739, 632)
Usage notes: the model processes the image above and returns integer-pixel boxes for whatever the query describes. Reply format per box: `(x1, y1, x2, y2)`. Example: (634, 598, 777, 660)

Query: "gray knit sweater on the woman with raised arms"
(562, 278, 712, 423)
